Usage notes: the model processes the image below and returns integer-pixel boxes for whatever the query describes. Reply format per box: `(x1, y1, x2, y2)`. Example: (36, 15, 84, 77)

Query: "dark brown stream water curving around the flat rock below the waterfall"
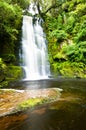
(0, 77, 86, 130)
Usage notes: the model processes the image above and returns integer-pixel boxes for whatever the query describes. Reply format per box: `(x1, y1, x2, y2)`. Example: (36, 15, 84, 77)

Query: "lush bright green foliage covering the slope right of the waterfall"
(41, 0, 86, 78)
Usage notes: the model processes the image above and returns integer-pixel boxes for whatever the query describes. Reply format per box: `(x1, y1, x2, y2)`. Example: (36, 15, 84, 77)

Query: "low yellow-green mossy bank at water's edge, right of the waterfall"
(53, 61, 86, 78)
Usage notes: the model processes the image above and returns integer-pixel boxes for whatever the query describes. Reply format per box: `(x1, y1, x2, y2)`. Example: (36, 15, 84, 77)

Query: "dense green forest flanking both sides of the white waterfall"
(0, 0, 86, 87)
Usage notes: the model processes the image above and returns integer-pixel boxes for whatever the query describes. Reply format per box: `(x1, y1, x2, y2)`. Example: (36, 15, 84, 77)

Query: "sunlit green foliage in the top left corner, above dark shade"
(0, 2, 22, 36)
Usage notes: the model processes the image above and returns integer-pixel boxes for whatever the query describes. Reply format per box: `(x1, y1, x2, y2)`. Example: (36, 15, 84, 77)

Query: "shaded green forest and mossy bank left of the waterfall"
(0, 0, 29, 87)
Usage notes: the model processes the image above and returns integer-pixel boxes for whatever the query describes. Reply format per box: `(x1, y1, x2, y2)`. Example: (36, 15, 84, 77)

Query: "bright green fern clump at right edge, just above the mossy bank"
(64, 42, 86, 63)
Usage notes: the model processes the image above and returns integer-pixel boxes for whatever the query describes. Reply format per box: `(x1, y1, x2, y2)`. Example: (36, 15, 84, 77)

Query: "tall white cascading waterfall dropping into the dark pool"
(22, 16, 50, 80)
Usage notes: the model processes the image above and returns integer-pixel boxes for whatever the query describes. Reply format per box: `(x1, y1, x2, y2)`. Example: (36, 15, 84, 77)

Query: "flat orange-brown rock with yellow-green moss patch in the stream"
(0, 88, 62, 117)
